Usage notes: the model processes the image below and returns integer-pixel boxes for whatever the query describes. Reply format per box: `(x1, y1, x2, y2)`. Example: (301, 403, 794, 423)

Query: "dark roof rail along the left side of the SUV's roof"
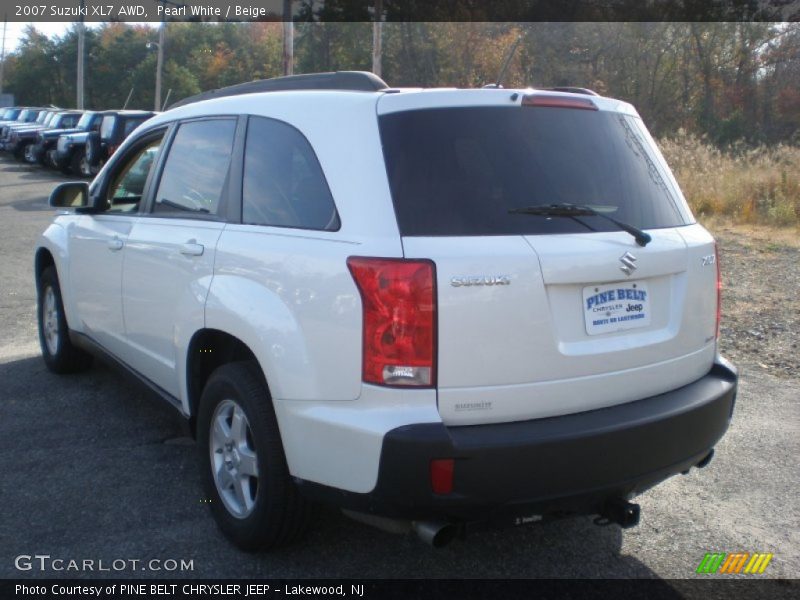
(170, 71, 389, 109)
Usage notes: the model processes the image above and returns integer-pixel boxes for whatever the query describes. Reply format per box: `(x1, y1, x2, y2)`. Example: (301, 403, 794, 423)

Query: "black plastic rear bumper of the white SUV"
(296, 358, 738, 520)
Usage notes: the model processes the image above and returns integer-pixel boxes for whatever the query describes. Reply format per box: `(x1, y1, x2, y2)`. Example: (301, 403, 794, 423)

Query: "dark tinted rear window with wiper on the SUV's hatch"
(380, 106, 689, 236)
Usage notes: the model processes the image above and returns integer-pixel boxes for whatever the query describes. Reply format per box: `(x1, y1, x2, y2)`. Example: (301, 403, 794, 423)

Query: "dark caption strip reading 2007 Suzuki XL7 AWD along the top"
(0, 0, 800, 22)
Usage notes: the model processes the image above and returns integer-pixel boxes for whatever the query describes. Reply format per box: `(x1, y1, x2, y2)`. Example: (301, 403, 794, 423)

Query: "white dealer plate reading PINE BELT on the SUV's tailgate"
(583, 281, 650, 335)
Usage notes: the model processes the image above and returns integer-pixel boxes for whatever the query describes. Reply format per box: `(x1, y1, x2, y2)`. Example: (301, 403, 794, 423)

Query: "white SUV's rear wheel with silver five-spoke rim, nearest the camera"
(197, 362, 309, 552)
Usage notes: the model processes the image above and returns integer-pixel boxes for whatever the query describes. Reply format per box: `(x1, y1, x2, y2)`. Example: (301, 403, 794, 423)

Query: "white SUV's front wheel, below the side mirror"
(36, 267, 92, 374)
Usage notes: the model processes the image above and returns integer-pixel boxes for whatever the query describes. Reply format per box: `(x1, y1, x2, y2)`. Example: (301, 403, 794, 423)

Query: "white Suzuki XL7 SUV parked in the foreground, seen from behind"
(35, 72, 737, 549)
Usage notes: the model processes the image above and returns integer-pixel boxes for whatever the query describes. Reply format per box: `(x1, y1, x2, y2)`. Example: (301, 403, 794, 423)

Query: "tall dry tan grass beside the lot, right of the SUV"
(659, 131, 800, 227)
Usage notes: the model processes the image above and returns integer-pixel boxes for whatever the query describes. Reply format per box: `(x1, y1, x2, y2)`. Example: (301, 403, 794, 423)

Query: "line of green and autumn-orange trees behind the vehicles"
(4, 19, 800, 146)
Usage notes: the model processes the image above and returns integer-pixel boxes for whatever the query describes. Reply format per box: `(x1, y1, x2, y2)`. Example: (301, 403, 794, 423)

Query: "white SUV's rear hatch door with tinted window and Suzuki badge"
(379, 90, 716, 425)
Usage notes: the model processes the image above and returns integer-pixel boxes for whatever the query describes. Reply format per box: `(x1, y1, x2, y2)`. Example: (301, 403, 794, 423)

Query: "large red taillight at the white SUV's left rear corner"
(347, 257, 436, 387)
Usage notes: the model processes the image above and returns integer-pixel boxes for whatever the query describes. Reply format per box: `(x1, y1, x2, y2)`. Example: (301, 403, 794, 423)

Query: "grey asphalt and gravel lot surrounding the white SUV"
(0, 159, 800, 580)
